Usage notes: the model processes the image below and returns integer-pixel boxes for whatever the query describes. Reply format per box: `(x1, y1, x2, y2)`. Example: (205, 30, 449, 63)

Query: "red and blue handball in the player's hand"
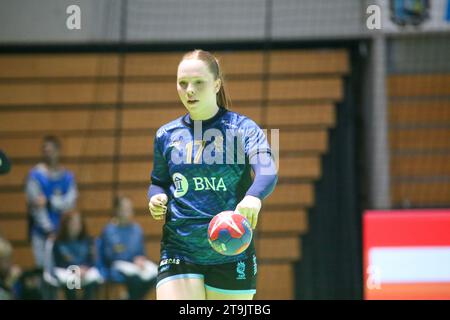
(208, 211, 253, 256)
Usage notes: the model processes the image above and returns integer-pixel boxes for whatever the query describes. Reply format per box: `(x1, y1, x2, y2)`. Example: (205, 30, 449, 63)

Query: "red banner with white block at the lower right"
(363, 209, 450, 299)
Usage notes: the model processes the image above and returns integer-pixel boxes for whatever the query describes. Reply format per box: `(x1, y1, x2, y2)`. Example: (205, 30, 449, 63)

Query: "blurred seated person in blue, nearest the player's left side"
(99, 197, 158, 300)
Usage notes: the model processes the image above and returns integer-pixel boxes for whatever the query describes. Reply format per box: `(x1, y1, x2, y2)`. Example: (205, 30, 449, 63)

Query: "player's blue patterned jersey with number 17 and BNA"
(151, 108, 270, 264)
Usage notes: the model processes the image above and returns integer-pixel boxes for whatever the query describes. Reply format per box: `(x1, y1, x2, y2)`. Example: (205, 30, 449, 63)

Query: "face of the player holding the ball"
(177, 59, 220, 112)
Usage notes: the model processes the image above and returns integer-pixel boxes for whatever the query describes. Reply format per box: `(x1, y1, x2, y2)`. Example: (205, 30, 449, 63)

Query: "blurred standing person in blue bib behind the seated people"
(25, 136, 78, 268)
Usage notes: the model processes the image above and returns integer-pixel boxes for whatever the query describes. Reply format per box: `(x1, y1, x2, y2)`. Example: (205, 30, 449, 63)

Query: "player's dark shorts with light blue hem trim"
(156, 254, 258, 294)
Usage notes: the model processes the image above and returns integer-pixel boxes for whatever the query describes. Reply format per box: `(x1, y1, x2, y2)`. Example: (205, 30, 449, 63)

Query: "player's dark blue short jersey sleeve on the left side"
(151, 129, 171, 188)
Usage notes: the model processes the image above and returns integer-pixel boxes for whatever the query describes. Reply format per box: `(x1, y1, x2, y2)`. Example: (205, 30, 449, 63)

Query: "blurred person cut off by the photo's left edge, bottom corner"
(0, 237, 21, 300)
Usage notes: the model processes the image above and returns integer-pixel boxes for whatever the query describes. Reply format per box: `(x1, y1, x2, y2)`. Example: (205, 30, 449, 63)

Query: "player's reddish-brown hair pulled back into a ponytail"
(181, 49, 231, 109)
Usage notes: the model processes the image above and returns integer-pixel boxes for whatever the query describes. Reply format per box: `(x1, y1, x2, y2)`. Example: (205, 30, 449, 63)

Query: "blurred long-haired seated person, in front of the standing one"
(51, 211, 103, 300)
